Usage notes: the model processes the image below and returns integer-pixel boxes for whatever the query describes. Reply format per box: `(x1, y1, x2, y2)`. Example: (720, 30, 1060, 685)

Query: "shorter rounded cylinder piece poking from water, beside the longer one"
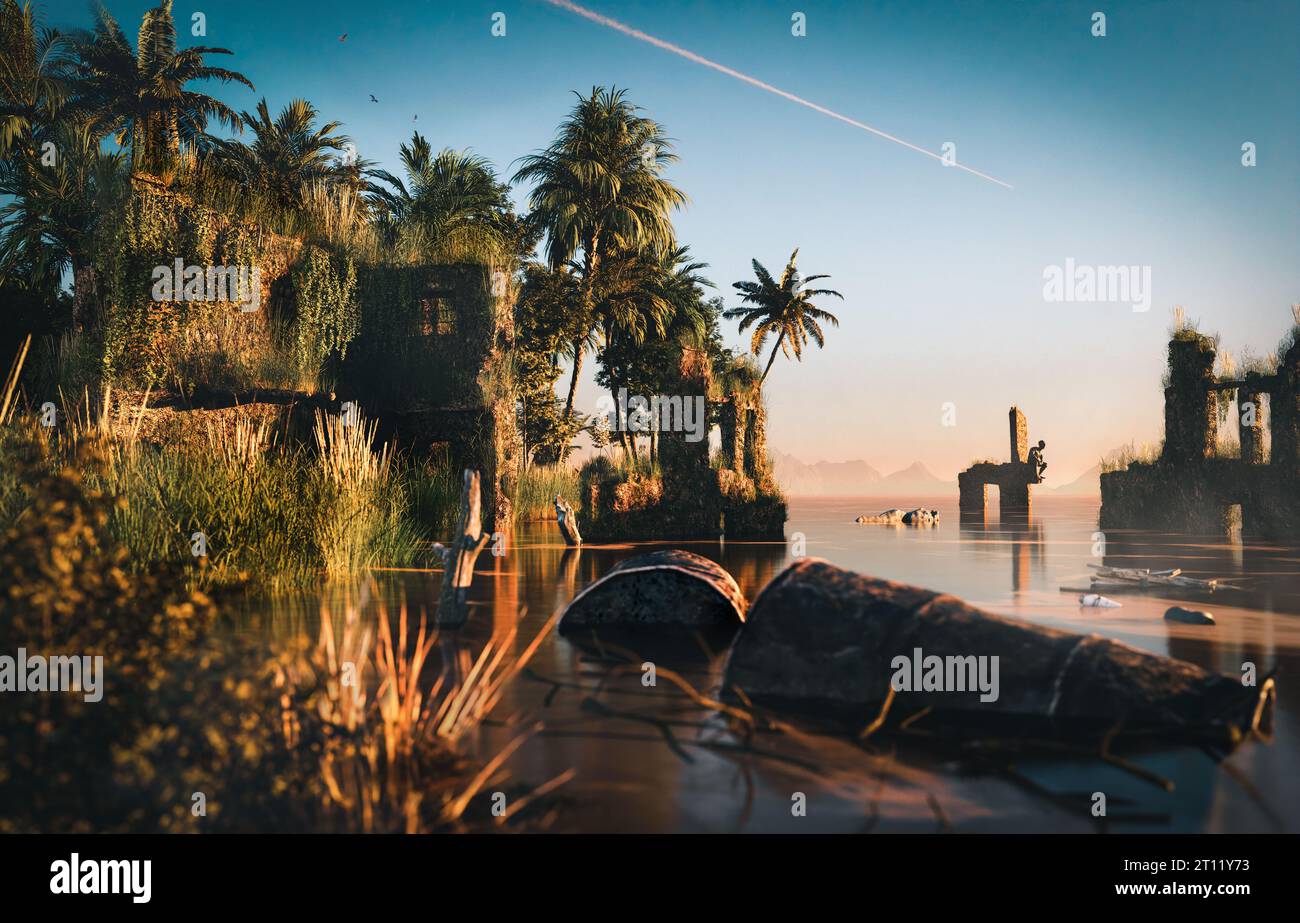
(560, 550, 746, 631)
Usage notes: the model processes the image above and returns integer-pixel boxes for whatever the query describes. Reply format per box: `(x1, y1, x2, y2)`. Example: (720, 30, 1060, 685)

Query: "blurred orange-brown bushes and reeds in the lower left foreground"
(0, 426, 572, 833)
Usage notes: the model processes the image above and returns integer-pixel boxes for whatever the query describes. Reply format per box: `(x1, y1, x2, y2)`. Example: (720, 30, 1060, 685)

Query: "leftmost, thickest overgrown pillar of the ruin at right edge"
(1161, 334, 1218, 464)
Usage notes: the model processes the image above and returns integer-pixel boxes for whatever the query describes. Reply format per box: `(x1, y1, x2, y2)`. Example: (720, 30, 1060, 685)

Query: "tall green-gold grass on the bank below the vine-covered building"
(0, 394, 459, 590)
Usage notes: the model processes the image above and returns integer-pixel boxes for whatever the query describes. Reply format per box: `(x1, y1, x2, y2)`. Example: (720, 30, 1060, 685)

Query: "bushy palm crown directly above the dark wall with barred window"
(367, 131, 510, 257)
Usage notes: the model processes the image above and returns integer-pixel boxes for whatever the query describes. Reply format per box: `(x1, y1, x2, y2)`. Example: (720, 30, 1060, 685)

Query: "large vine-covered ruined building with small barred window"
(94, 177, 520, 530)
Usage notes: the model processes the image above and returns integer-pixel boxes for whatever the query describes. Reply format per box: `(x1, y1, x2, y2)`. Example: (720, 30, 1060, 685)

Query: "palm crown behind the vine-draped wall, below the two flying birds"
(212, 98, 350, 212)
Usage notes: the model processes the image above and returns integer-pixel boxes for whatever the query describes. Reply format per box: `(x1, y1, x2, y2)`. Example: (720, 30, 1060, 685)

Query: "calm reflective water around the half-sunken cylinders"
(236, 498, 1300, 832)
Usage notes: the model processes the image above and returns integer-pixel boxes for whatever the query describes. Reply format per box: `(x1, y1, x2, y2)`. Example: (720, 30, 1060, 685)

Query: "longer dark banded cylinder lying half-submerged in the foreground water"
(723, 559, 1274, 746)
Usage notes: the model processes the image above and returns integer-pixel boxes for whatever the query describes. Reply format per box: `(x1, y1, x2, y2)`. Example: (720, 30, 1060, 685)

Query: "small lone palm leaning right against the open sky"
(723, 248, 844, 387)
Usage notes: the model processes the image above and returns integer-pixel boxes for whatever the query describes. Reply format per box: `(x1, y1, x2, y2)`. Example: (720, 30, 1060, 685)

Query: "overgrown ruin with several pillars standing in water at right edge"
(1101, 329, 1300, 538)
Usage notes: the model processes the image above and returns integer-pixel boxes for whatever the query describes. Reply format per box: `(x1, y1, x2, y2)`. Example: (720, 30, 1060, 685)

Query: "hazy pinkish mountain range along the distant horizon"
(772, 451, 1101, 498)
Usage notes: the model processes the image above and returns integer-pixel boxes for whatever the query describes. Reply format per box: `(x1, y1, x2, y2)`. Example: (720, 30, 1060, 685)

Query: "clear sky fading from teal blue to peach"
(42, 0, 1300, 484)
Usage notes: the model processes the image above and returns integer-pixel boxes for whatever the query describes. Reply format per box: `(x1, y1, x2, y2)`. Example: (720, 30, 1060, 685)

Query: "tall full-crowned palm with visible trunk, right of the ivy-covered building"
(515, 87, 686, 416)
